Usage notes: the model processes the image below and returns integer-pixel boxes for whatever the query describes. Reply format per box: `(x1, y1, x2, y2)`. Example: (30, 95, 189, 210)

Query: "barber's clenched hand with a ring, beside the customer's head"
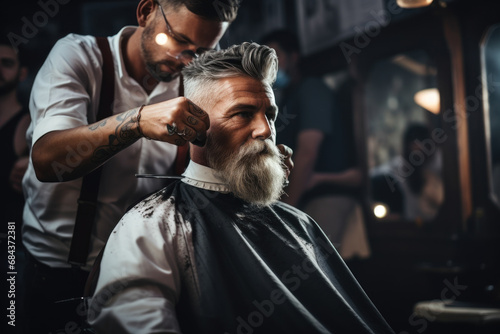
(139, 97, 210, 146)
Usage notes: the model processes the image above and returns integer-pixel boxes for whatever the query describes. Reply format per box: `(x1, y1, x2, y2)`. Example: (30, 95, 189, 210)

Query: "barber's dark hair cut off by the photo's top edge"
(158, 0, 241, 22)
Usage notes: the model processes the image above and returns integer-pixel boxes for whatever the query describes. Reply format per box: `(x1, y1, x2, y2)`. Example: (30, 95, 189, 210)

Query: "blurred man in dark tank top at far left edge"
(0, 34, 30, 332)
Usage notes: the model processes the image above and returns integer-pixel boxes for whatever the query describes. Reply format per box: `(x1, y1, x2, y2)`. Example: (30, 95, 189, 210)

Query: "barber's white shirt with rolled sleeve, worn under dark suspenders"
(23, 27, 179, 267)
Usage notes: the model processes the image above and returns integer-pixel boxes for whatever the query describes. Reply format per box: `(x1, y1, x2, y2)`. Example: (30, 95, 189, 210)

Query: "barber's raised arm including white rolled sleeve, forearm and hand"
(30, 37, 209, 182)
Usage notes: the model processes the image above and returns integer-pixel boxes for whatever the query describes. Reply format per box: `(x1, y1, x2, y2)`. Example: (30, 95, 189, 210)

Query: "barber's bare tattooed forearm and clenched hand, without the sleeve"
(32, 97, 210, 182)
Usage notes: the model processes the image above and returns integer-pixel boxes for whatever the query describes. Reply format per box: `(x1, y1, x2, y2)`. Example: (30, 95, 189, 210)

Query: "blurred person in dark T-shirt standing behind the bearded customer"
(261, 29, 369, 258)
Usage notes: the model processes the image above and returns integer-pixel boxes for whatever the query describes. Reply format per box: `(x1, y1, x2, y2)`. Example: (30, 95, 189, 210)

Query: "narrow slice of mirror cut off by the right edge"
(481, 24, 500, 205)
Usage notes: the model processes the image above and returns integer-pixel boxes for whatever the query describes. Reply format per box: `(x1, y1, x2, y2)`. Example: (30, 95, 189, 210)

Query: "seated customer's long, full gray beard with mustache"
(206, 136, 286, 206)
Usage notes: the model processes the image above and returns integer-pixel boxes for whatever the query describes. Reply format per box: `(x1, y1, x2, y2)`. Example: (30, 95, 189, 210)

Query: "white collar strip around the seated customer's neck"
(181, 160, 229, 193)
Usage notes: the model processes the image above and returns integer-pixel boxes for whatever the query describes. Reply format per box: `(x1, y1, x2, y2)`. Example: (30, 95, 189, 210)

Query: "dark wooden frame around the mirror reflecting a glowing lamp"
(351, 11, 464, 237)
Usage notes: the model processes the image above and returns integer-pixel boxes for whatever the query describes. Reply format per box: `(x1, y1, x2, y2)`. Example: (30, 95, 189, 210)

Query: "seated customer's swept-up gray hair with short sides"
(182, 42, 278, 97)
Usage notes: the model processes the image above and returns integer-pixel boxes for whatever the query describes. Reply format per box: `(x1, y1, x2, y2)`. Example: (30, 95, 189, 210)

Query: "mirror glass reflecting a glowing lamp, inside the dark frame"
(365, 50, 446, 224)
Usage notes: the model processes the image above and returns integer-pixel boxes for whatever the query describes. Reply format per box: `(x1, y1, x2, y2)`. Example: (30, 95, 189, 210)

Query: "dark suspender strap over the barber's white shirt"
(68, 37, 115, 266)
